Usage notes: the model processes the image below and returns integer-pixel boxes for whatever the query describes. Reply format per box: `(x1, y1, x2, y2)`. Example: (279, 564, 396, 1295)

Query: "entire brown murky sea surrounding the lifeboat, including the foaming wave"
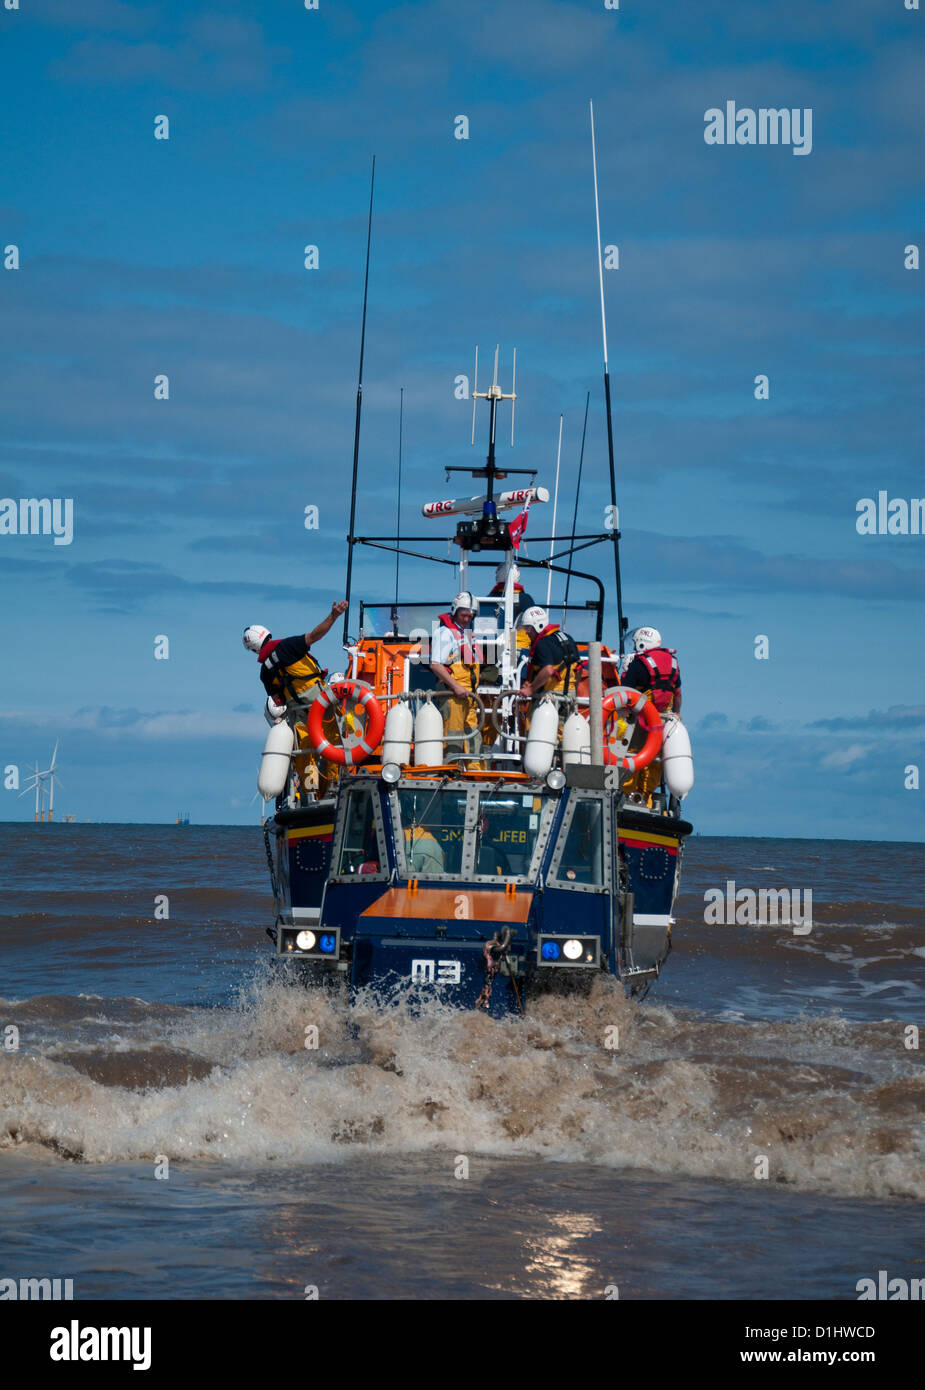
(0, 826, 925, 1298)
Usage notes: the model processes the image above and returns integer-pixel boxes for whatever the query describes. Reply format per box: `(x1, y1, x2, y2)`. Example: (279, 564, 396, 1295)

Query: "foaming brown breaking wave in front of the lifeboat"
(0, 980, 925, 1200)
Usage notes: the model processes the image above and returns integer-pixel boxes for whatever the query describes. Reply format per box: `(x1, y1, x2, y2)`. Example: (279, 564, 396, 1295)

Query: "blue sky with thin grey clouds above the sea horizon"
(0, 0, 925, 840)
